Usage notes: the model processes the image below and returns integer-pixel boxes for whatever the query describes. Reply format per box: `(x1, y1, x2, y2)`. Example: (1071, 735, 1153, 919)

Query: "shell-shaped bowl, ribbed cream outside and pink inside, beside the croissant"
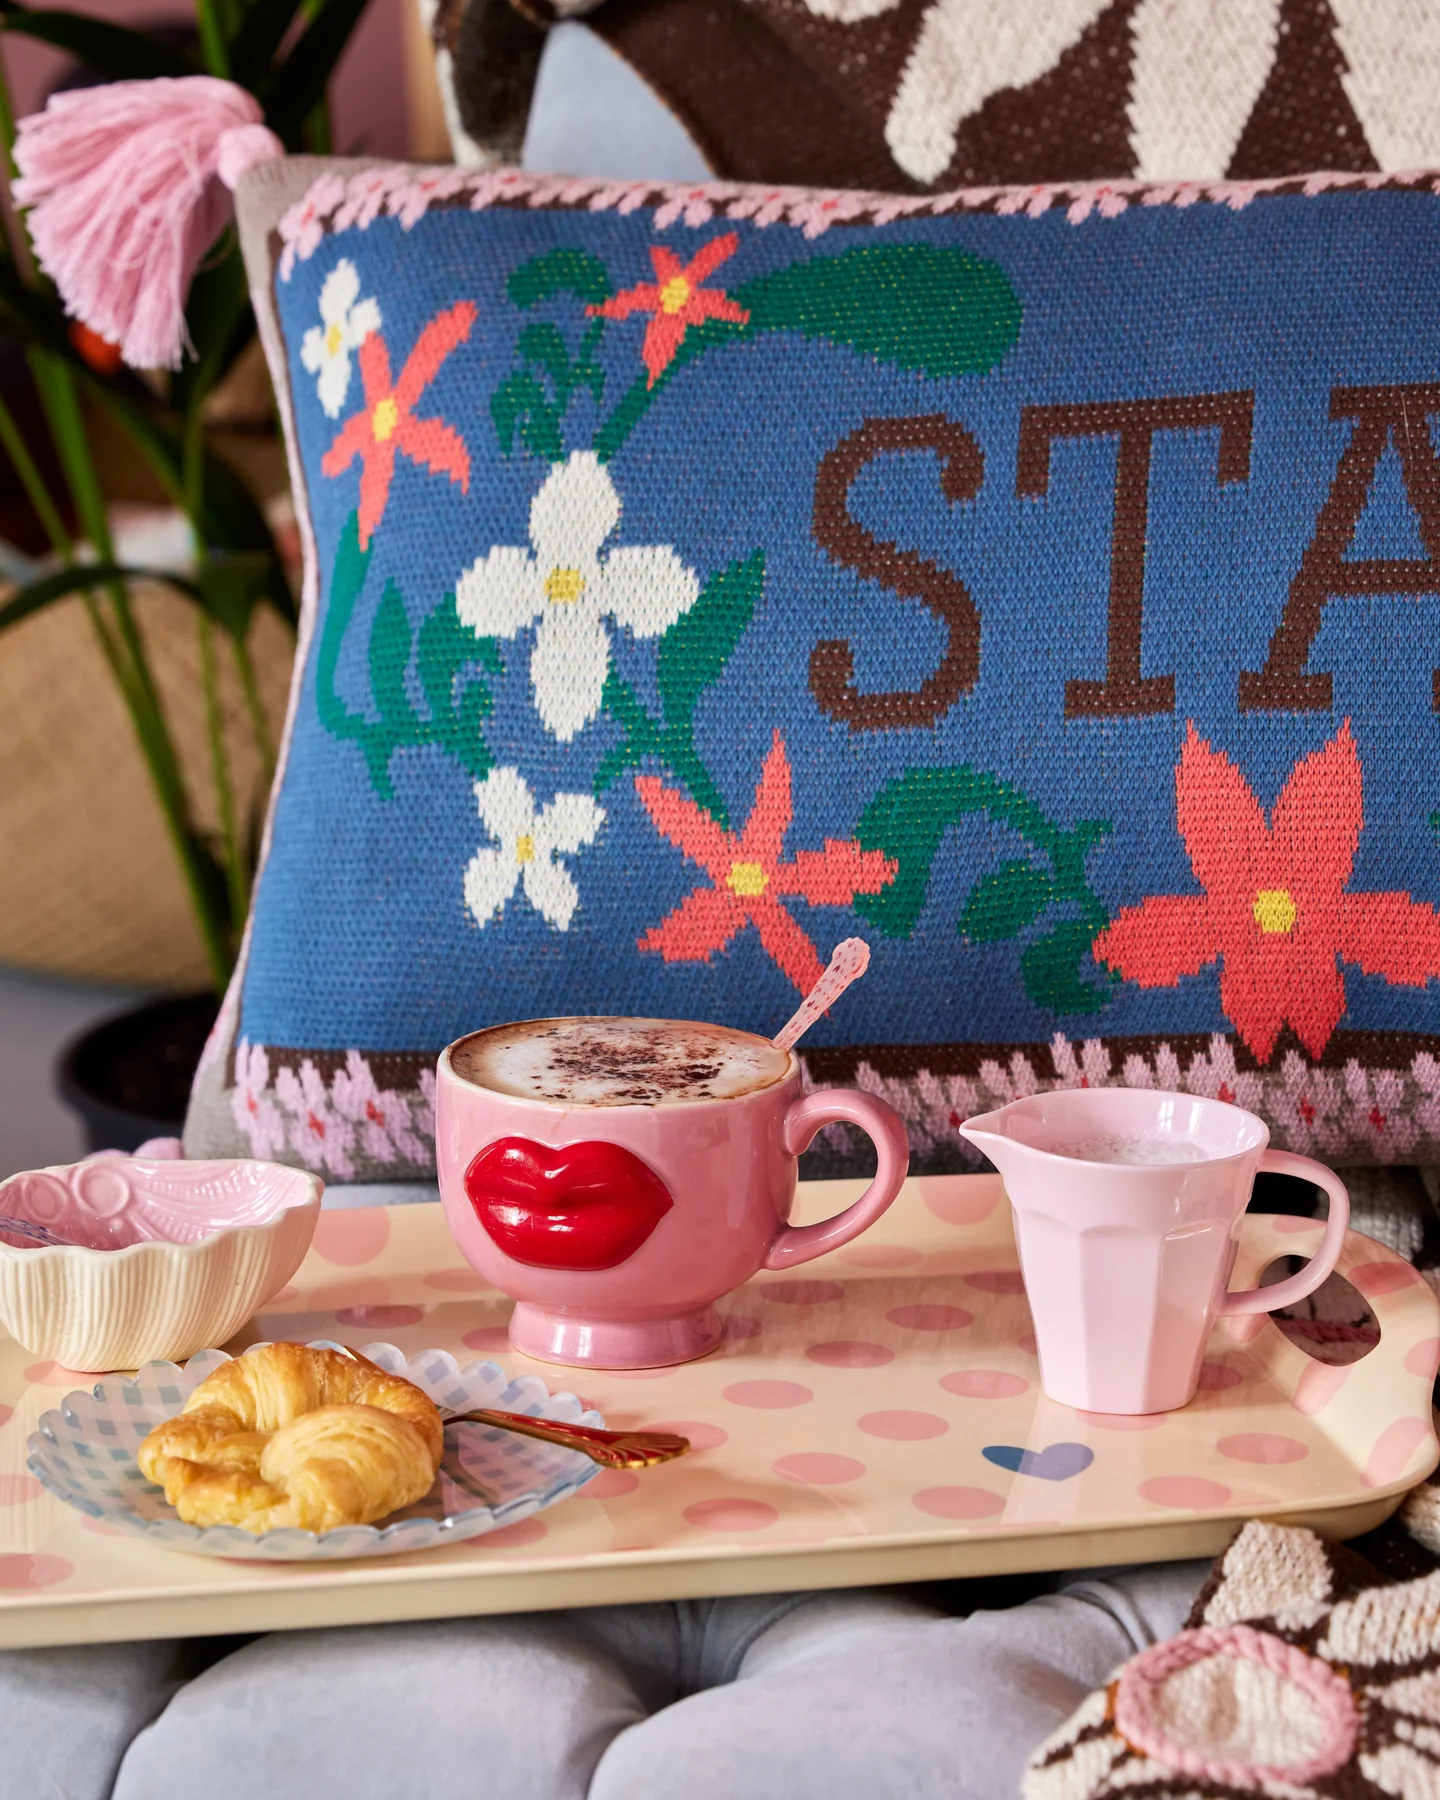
(0, 1156, 324, 1370)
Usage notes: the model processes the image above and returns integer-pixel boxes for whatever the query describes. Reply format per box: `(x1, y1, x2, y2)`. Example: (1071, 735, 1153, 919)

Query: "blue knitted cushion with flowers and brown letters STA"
(187, 162, 1440, 1179)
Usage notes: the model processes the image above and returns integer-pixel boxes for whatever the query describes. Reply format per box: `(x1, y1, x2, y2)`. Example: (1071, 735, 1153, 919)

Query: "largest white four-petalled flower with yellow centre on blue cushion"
(455, 450, 700, 743)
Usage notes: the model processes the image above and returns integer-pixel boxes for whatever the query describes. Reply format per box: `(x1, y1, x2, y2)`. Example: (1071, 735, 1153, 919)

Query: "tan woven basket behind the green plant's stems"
(0, 585, 293, 988)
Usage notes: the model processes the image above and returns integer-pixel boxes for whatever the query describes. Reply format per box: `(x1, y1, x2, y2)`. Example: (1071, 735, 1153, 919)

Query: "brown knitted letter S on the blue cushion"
(810, 412, 985, 731)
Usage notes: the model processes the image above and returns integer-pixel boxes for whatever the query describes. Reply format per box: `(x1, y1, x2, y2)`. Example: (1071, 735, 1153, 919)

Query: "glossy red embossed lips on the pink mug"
(464, 1138, 675, 1269)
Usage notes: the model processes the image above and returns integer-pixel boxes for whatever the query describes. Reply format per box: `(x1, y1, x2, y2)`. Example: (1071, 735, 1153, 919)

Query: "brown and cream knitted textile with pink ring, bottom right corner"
(1024, 1523, 1440, 1800)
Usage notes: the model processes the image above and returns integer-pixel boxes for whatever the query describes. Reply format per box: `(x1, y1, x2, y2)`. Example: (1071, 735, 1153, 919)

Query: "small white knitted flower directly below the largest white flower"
(464, 769, 605, 931)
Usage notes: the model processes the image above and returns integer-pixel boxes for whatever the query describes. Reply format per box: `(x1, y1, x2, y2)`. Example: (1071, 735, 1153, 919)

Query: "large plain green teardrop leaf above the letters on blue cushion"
(734, 243, 1021, 376)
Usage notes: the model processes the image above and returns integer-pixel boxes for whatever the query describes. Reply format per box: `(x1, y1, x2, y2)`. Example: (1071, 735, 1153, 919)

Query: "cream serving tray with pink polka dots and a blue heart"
(0, 1175, 1440, 1647)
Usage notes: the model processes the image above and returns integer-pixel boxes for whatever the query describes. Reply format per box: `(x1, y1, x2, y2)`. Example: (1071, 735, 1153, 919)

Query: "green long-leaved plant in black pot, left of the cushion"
(0, 0, 376, 1148)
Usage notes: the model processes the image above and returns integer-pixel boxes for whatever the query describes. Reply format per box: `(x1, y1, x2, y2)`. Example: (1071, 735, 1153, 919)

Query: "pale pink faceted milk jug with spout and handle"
(959, 1087, 1350, 1413)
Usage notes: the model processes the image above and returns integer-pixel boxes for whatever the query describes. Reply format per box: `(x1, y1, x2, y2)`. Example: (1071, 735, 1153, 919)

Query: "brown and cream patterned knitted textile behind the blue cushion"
(427, 0, 1440, 193)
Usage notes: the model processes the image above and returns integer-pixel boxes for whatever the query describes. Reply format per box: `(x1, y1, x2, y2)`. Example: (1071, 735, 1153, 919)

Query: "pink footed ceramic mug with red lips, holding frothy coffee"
(436, 1021, 909, 1368)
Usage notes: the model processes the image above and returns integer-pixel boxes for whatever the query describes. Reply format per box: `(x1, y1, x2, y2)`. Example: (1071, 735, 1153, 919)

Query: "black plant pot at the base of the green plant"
(56, 994, 220, 1150)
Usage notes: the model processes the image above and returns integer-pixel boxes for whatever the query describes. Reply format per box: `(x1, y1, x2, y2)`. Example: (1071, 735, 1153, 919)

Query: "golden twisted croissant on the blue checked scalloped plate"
(139, 1345, 445, 1532)
